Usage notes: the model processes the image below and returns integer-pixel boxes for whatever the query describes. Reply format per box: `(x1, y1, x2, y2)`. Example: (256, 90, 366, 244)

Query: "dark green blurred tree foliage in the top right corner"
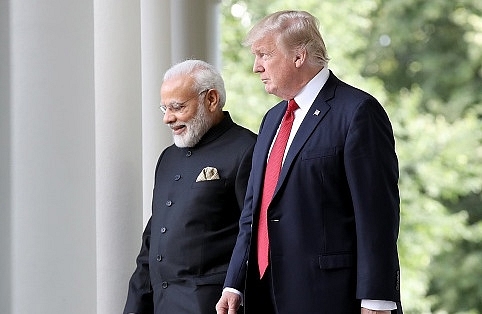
(355, 0, 482, 121)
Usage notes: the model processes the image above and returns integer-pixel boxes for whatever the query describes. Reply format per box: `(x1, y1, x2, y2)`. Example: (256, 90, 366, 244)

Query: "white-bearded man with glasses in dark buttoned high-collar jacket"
(124, 60, 256, 314)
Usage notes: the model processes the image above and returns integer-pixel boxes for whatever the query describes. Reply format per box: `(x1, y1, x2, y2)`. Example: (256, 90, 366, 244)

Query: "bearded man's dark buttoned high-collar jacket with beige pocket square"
(124, 112, 256, 314)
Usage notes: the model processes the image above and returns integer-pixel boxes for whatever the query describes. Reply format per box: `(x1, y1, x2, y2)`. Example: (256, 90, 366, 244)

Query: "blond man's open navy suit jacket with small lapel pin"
(225, 73, 401, 314)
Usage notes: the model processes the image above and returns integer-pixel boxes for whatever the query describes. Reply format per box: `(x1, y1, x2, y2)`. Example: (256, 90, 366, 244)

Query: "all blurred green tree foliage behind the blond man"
(221, 0, 482, 313)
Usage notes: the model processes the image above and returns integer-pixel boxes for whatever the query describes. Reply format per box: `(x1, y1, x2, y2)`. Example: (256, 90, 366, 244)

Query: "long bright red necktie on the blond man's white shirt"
(257, 99, 298, 277)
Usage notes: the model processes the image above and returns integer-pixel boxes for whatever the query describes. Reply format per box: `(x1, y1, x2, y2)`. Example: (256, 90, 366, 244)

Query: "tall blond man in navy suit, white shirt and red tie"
(216, 11, 401, 314)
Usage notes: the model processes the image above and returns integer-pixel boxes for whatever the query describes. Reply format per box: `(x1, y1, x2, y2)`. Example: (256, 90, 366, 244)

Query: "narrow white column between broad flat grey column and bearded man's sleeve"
(94, 0, 143, 313)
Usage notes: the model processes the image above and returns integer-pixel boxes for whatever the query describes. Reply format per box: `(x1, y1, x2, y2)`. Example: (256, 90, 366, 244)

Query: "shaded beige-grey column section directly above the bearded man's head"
(171, 0, 221, 68)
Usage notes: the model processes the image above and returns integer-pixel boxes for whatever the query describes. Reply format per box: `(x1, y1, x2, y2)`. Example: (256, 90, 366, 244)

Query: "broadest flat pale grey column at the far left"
(8, 0, 96, 314)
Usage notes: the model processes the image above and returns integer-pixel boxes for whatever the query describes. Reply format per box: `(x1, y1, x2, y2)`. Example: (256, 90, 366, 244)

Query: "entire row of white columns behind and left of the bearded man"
(0, 0, 220, 314)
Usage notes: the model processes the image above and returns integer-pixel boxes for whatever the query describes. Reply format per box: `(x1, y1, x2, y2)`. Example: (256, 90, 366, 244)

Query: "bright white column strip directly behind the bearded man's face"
(141, 0, 172, 226)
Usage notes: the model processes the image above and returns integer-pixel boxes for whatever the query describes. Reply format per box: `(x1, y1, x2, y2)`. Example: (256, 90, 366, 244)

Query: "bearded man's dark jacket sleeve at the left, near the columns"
(124, 219, 154, 314)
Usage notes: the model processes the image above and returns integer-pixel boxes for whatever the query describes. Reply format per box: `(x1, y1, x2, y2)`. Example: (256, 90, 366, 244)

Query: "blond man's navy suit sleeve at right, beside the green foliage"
(345, 98, 400, 301)
